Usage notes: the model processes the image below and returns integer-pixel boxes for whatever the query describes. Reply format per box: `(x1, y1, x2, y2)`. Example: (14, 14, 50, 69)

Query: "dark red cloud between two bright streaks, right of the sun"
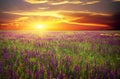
(61, 11, 113, 25)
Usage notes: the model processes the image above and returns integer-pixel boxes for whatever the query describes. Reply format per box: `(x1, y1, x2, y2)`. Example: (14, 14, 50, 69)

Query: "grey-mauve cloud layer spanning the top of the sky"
(0, 0, 120, 13)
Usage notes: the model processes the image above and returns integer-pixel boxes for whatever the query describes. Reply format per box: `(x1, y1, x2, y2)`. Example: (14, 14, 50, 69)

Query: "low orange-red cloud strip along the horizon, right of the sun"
(50, 22, 111, 30)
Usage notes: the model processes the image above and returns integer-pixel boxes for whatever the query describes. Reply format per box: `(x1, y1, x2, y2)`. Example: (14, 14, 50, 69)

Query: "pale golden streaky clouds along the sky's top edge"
(25, 0, 100, 5)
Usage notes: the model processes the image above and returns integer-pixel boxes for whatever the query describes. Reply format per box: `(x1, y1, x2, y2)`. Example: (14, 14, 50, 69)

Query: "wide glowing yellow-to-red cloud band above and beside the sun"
(1, 10, 111, 29)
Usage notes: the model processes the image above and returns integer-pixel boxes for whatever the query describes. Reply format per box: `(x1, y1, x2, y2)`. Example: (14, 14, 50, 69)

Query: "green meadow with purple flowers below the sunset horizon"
(0, 31, 120, 79)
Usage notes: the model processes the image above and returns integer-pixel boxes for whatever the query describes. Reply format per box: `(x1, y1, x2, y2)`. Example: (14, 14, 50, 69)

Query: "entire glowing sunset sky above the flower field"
(0, 0, 120, 30)
